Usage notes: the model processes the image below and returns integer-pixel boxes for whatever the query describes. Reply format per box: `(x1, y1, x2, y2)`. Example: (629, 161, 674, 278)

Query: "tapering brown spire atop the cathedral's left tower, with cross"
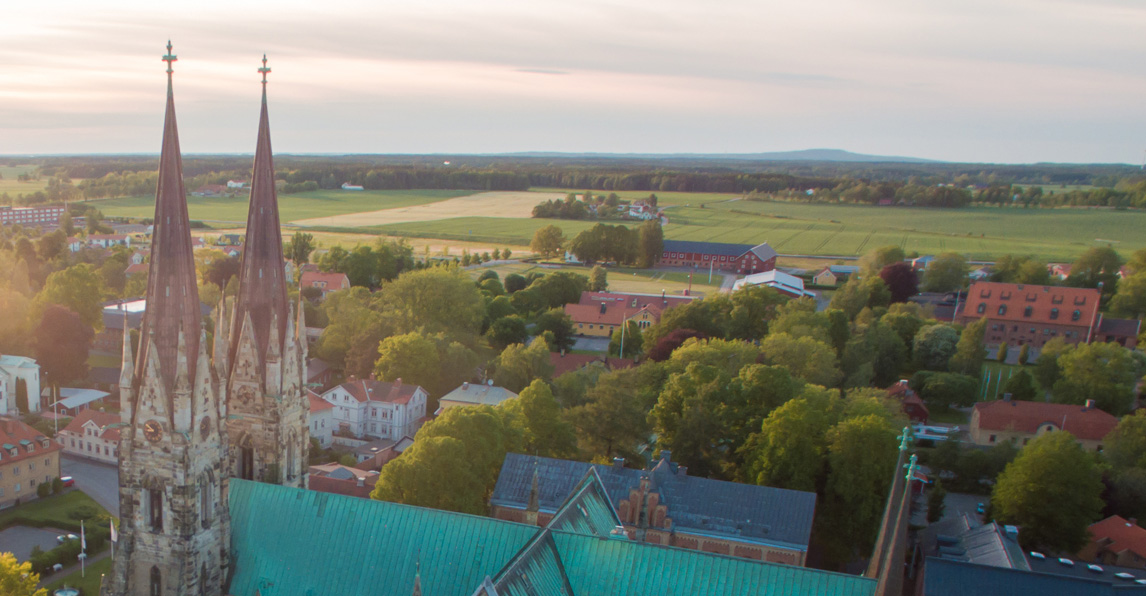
(135, 41, 201, 395)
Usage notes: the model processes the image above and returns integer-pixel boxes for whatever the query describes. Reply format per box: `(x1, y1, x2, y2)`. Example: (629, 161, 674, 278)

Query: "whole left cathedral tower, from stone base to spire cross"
(103, 42, 230, 596)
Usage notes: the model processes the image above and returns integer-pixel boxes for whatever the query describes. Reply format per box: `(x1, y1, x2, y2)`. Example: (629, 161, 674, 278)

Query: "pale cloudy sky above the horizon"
(0, 0, 1146, 164)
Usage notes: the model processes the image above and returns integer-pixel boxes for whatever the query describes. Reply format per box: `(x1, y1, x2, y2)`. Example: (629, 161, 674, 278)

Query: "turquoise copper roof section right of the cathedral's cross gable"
(552, 532, 876, 596)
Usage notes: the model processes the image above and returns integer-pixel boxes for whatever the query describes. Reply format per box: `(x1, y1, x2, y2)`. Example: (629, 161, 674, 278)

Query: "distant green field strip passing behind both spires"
(83, 190, 473, 224)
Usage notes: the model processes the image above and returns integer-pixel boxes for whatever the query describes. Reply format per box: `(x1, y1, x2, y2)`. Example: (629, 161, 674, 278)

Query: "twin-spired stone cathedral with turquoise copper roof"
(101, 42, 910, 596)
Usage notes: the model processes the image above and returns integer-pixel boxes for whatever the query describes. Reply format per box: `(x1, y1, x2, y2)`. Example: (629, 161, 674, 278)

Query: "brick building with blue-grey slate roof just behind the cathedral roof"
(489, 450, 816, 566)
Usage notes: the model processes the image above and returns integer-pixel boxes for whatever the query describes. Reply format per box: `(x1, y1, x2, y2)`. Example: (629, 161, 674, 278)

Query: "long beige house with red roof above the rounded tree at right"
(971, 398, 1118, 452)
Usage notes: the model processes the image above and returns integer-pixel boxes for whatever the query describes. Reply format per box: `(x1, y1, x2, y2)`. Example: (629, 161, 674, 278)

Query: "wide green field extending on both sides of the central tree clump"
(368, 201, 1146, 260)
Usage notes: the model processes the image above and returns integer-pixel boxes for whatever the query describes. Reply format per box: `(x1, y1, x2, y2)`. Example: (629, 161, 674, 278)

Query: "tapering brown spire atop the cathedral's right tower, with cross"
(228, 56, 288, 369)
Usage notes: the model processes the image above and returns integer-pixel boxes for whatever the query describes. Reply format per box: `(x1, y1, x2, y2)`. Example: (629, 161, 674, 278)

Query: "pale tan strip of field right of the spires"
(295, 191, 565, 227)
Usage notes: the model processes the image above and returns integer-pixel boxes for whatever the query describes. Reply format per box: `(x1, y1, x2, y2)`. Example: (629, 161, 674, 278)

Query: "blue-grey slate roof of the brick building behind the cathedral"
(490, 453, 816, 550)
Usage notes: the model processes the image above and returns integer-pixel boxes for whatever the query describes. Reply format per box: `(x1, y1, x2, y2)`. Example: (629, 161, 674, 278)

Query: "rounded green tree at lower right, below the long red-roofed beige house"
(991, 431, 1102, 552)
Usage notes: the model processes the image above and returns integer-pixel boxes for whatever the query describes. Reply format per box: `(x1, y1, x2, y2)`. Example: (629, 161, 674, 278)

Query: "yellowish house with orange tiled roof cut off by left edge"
(0, 416, 61, 508)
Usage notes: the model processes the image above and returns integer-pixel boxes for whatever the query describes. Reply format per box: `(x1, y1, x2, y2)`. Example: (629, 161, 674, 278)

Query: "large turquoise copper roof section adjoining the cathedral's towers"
(229, 479, 537, 596)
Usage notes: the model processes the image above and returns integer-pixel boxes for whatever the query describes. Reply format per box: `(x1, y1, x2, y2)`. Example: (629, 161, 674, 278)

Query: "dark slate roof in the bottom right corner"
(923, 557, 1146, 596)
